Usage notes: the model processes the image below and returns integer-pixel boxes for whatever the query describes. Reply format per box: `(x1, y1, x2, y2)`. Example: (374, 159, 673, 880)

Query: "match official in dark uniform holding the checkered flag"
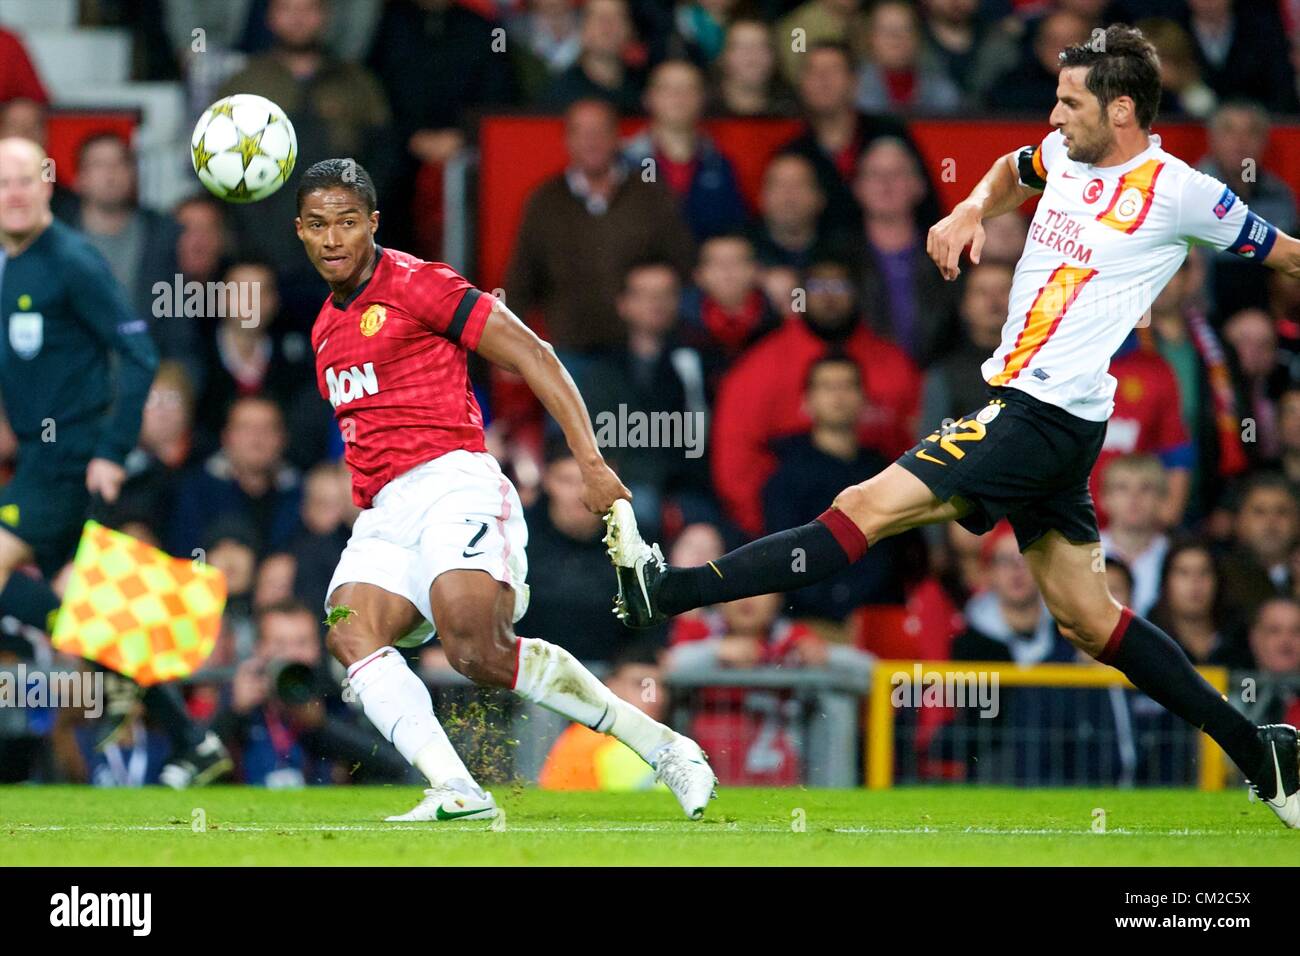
(0, 138, 230, 787)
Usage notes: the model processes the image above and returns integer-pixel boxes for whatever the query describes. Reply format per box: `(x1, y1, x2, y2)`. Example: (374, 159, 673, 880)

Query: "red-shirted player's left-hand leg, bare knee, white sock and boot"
(326, 584, 497, 822)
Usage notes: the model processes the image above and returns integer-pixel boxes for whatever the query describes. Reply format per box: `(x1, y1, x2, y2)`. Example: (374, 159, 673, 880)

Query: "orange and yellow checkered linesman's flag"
(51, 522, 226, 687)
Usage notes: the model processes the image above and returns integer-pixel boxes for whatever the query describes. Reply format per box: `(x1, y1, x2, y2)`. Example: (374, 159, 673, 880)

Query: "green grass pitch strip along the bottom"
(0, 787, 1300, 866)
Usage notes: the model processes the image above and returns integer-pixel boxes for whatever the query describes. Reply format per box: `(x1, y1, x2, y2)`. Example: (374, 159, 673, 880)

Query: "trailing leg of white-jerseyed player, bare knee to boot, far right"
(1024, 531, 1300, 829)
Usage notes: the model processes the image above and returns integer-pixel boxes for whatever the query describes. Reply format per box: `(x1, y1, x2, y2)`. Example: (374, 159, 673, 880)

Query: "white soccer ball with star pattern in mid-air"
(190, 92, 298, 203)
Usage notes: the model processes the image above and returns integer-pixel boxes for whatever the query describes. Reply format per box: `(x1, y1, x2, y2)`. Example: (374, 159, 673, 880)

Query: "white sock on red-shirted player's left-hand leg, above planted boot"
(346, 648, 478, 787)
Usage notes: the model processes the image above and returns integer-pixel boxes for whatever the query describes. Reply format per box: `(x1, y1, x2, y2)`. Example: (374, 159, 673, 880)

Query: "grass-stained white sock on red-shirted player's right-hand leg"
(515, 637, 677, 763)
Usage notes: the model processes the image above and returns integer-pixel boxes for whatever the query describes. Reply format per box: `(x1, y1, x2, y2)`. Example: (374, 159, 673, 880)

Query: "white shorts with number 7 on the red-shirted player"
(325, 450, 528, 648)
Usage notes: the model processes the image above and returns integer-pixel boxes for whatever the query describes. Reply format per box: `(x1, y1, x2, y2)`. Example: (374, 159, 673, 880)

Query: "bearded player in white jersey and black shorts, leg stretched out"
(607, 25, 1300, 827)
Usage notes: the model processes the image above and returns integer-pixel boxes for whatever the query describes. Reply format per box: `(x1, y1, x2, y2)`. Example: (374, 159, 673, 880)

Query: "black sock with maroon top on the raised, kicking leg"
(655, 509, 867, 615)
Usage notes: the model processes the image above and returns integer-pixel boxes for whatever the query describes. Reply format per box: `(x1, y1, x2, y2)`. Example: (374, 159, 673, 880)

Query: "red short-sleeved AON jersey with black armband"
(312, 248, 497, 507)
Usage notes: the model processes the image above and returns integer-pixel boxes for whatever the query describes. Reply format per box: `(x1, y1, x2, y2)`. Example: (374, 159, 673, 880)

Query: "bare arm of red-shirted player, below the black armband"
(477, 303, 632, 515)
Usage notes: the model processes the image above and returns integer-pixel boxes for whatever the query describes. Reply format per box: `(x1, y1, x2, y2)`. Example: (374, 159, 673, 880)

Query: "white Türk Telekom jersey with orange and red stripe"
(980, 130, 1275, 421)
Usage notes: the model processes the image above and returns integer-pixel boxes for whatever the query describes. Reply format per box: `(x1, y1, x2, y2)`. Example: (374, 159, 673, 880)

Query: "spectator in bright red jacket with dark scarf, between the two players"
(711, 259, 920, 535)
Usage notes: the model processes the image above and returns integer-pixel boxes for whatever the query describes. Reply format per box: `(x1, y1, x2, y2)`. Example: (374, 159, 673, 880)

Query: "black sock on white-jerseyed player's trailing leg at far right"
(1097, 607, 1268, 784)
